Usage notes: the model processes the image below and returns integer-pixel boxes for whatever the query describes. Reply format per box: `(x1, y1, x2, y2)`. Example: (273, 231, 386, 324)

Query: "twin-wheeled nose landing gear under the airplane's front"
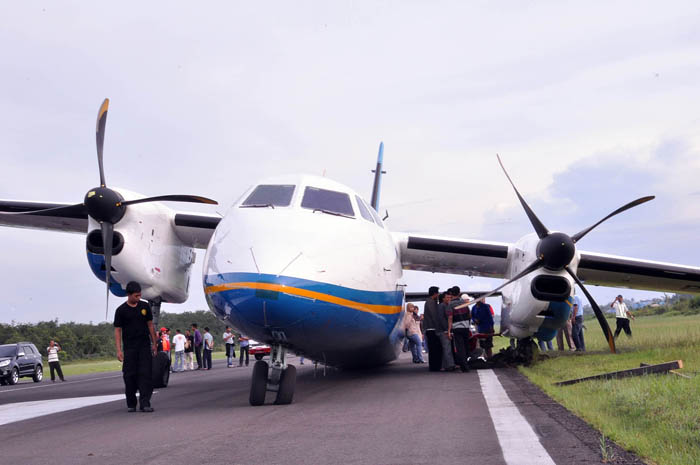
(250, 344, 297, 405)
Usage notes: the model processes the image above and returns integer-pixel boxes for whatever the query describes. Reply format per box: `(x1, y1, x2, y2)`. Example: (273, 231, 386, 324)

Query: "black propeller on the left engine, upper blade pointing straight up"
(9, 99, 218, 319)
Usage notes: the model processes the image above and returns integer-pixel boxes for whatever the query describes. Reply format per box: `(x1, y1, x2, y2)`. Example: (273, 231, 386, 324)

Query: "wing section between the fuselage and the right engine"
(394, 233, 508, 278)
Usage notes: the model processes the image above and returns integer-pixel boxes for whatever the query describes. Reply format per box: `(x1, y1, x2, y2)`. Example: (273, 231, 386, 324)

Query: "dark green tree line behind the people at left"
(0, 310, 235, 361)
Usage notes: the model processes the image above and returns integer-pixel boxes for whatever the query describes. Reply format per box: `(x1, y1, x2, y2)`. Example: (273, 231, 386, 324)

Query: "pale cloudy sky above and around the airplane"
(0, 1, 700, 322)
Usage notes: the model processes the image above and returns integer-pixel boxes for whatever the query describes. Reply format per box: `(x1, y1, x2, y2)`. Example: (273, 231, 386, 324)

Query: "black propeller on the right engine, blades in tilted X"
(457, 155, 654, 353)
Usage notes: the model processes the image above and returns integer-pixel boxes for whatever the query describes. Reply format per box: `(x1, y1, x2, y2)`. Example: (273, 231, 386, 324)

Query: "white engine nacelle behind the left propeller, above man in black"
(86, 189, 196, 303)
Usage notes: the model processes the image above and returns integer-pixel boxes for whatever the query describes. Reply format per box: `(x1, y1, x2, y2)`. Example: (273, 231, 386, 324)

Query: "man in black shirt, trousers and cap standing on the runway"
(114, 281, 158, 412)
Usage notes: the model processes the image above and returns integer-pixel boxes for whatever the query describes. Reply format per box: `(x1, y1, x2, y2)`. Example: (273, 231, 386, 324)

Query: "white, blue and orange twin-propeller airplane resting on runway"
(0, 99, 700, 405)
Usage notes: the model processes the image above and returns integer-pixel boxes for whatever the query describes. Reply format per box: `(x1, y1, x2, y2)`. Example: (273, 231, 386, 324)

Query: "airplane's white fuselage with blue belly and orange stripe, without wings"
(203, 176, 403, 365)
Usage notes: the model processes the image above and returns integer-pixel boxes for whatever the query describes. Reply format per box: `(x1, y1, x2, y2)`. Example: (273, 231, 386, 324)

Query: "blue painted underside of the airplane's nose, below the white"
(204, 273, 404, 365)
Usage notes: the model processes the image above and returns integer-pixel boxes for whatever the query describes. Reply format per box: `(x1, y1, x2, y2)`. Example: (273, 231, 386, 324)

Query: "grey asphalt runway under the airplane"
(0, 354, 643, 465)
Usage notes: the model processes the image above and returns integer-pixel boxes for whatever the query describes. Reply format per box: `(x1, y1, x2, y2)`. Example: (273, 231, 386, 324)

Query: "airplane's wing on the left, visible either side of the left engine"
(0, 200, 221, 249)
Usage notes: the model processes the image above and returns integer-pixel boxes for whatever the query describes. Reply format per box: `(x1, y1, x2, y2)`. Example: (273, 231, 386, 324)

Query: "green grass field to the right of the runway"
(521, 315, 700, 465)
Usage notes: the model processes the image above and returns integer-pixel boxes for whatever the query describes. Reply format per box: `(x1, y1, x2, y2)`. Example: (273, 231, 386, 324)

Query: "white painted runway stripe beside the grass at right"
(478, 370, 555, 465)
